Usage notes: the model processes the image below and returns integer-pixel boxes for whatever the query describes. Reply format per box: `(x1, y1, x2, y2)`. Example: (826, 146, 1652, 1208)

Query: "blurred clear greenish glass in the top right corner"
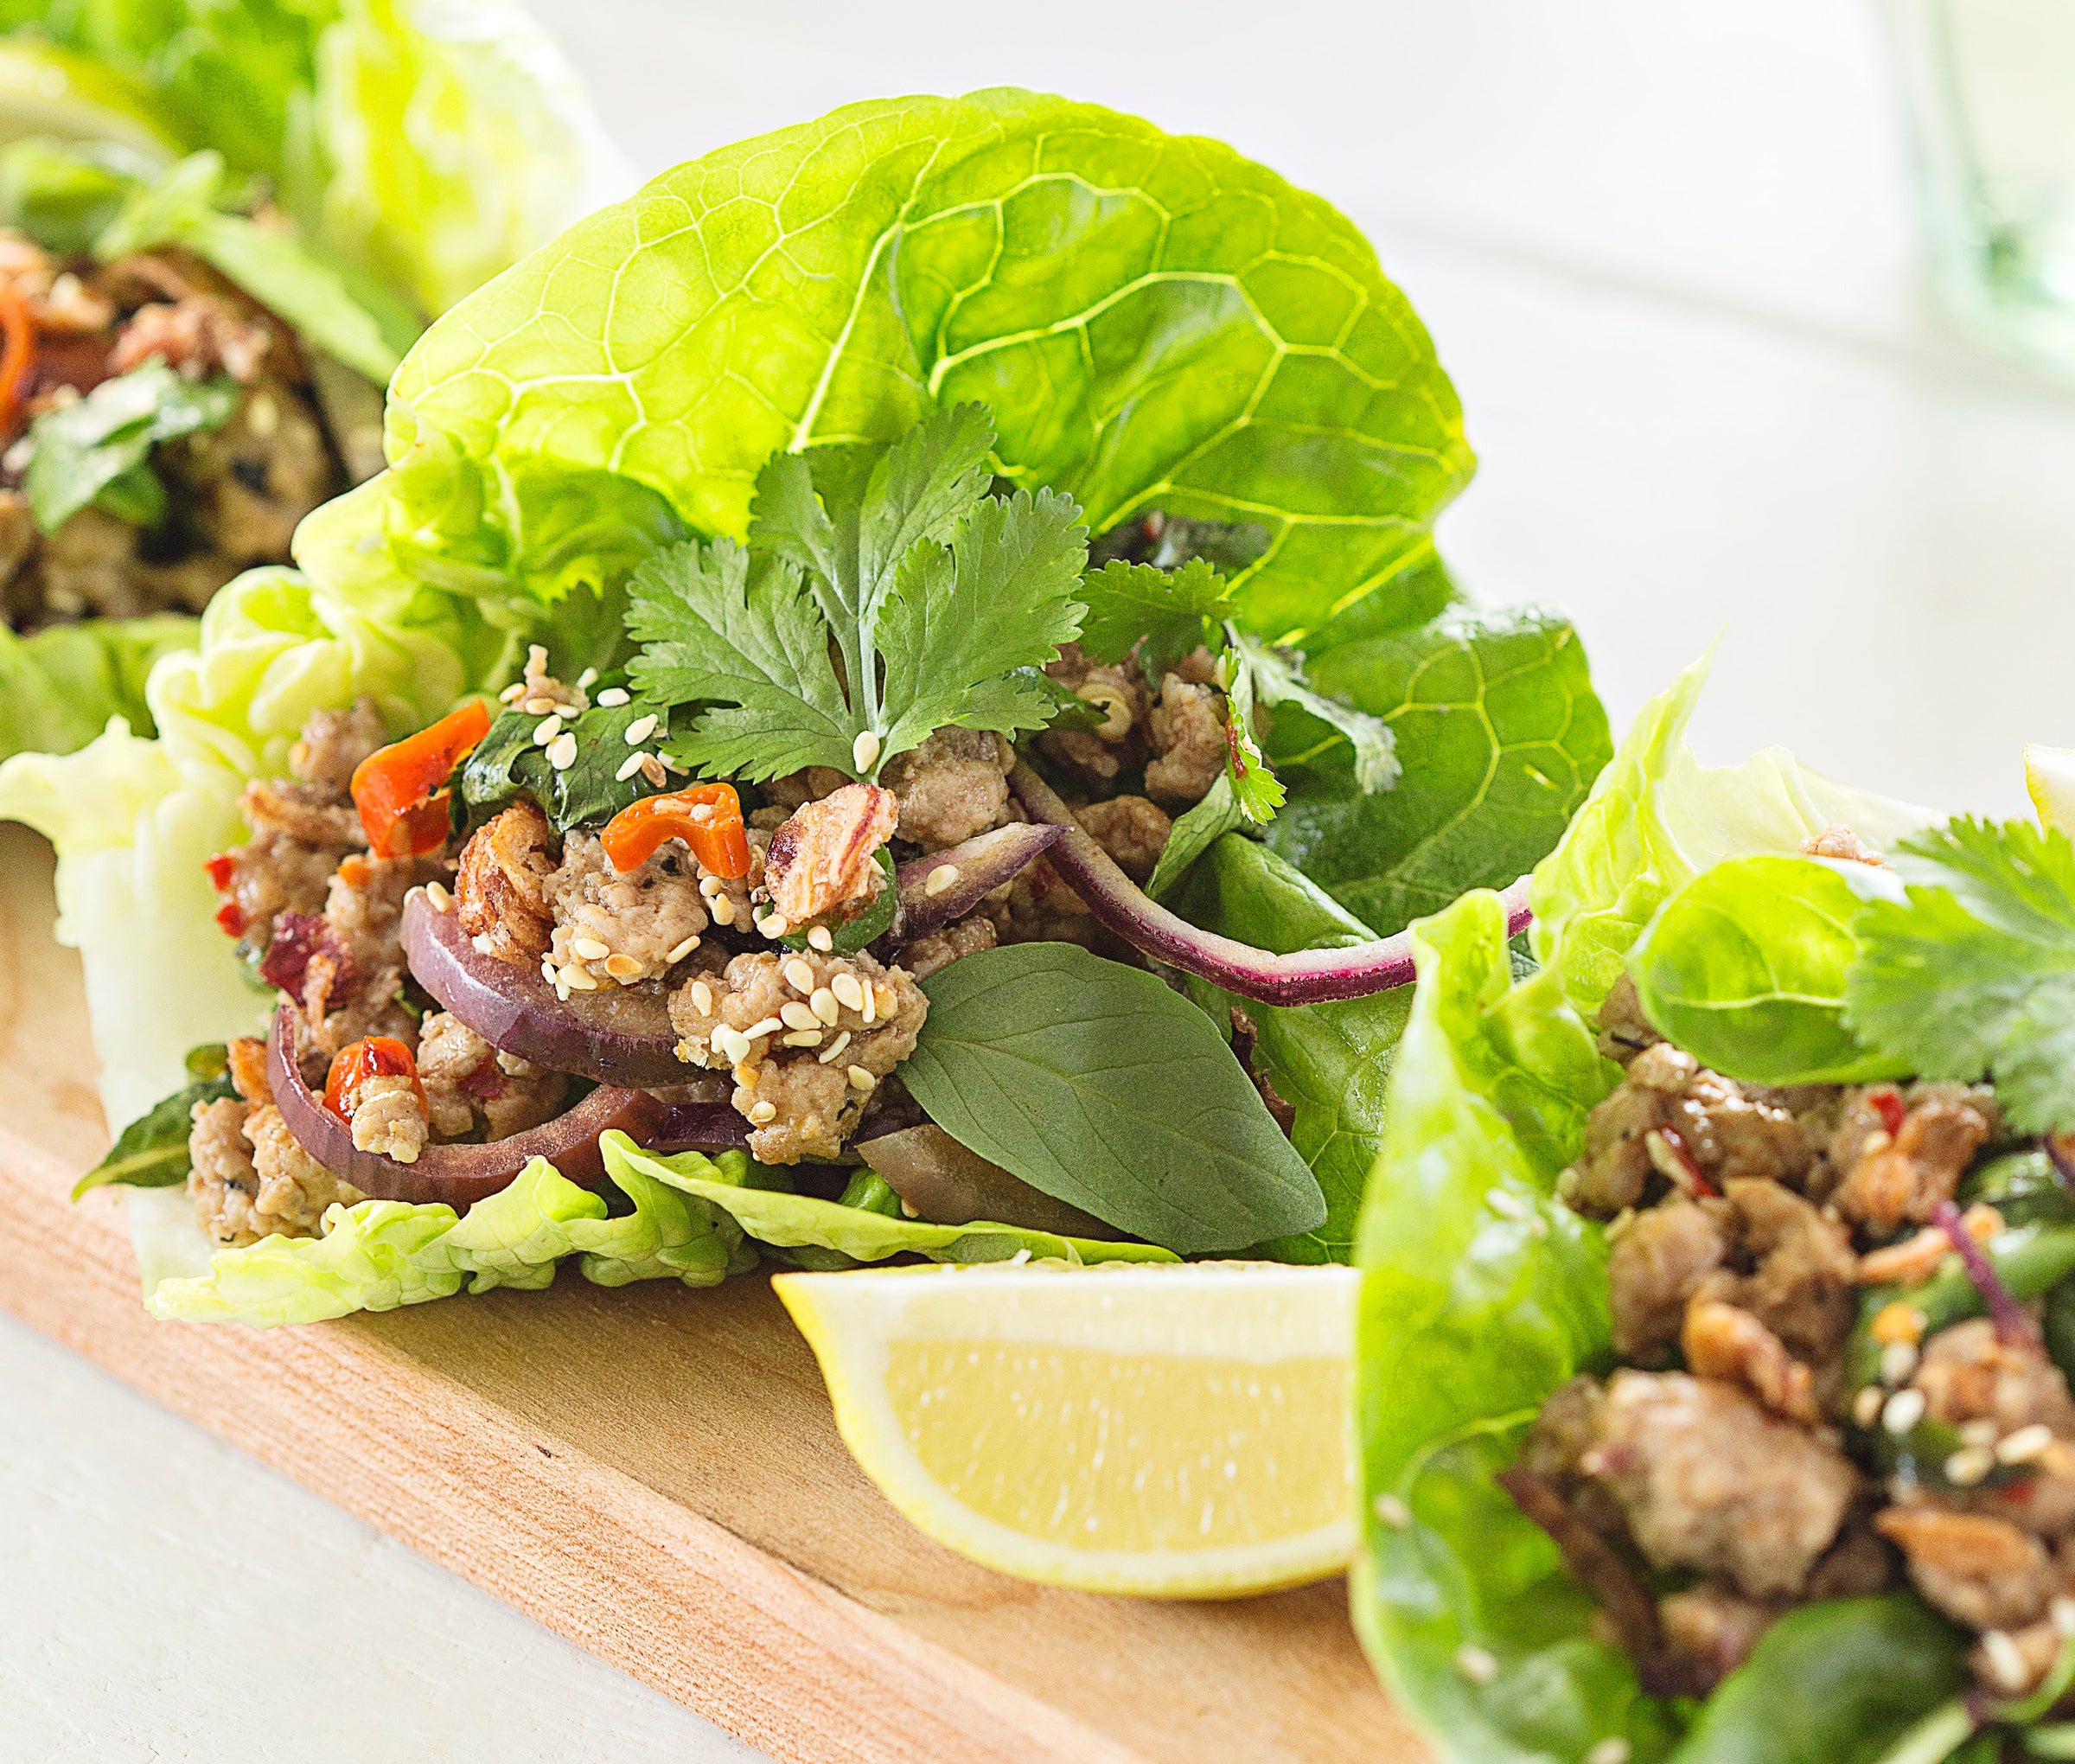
(1887, 0, 2075, 380)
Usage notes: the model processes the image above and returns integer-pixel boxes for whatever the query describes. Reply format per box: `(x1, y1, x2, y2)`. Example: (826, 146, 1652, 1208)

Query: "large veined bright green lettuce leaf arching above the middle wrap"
(388, 92, 1472, 635)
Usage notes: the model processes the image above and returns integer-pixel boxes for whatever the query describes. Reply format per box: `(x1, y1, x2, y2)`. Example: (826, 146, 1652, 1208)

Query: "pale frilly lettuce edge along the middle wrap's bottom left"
(145, 1152, 753, 1328)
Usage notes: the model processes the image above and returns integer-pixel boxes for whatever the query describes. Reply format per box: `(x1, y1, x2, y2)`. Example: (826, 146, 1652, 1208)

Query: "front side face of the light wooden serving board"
(0, 1131, 1140, 1764)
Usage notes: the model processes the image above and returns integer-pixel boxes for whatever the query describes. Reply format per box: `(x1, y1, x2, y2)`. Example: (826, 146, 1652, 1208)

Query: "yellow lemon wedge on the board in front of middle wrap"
(772, 1262, 1359, 1598)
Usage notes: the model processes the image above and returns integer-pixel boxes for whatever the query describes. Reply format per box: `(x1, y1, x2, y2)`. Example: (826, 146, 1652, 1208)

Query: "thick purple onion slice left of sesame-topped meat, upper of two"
(403, 888, 689, 1085)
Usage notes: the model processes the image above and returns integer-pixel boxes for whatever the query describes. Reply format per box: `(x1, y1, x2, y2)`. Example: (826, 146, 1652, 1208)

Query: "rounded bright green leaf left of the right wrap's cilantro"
(1629, 855, 1911, 1083)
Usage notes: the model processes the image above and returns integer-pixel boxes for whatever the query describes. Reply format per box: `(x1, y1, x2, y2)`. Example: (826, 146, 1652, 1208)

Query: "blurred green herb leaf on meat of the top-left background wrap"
(22, 361, 239, 534)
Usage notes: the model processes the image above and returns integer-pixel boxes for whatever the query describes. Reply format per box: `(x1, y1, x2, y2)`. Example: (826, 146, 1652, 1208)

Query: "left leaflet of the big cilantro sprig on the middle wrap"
(627, 540, 861, 780)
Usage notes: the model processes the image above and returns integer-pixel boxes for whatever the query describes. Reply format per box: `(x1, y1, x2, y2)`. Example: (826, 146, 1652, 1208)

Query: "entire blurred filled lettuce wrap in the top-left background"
(0, 0, 622, 756)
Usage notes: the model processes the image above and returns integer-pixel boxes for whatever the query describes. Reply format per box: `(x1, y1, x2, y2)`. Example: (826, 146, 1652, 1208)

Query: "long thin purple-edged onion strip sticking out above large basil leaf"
(1008, 759, 1534, 1005)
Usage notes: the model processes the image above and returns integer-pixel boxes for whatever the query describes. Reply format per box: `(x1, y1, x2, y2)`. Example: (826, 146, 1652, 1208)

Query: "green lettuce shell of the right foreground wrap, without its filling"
(1353, 651, 2008, 1764)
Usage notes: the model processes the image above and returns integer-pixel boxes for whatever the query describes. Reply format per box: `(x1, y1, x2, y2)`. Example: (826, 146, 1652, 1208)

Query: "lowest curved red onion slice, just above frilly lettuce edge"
(265, 1007, 668, 1208)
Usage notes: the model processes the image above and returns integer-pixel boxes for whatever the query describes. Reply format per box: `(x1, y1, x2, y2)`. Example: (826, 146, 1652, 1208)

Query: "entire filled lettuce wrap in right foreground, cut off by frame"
(1355, 651, 2075, 1764)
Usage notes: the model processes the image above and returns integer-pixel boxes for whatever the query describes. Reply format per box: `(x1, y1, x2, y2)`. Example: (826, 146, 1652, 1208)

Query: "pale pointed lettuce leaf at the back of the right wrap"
(1527, 660, 1936, 1017)
